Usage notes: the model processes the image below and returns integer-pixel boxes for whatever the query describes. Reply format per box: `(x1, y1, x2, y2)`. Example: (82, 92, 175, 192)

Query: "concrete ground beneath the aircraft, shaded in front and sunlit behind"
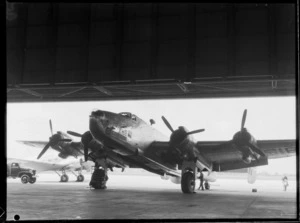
(6, 173, 298, 220)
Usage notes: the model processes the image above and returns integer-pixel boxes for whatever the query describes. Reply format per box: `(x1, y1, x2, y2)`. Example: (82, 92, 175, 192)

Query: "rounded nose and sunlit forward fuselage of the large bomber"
(90, 110, 169, 155)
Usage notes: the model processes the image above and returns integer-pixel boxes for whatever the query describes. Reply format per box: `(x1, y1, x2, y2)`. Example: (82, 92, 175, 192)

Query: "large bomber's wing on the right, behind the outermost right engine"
(197, 140, 296, 171)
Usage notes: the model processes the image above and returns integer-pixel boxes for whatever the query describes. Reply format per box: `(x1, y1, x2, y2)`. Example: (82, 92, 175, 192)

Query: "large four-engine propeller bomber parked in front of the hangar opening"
(18, 110, 295, 193)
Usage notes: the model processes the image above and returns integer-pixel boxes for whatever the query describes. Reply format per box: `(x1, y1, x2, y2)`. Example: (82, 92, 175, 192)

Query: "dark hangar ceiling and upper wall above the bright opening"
(6, 2, 296, 102)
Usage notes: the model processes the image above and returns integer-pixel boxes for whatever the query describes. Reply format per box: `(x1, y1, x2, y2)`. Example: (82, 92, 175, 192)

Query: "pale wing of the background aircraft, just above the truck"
(7, 158, 79, 172)
